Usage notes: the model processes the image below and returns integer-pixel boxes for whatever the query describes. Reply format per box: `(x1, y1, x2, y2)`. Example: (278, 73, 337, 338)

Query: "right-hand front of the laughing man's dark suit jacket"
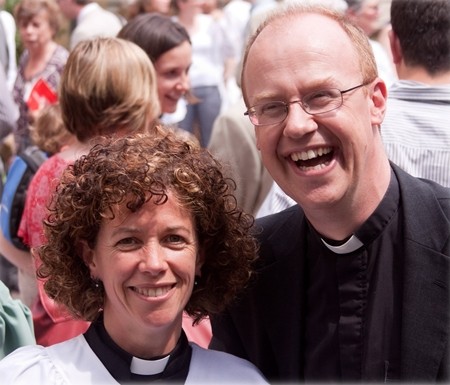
(394, 168, 450, 381)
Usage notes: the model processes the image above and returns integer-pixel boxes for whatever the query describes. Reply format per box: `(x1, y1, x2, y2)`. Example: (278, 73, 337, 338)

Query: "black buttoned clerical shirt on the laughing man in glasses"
(304, 173, 403, 382)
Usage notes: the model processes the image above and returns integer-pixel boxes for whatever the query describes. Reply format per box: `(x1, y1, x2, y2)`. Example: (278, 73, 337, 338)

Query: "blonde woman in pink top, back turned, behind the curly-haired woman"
(14, 38, 160, 346)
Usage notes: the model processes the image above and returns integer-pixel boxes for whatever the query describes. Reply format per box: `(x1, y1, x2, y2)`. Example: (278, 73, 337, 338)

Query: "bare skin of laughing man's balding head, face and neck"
(243, 14, 390, 240)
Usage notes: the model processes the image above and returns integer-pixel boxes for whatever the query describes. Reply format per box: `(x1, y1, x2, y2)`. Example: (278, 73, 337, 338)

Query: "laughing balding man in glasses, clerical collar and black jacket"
(211, 6, 450, 382)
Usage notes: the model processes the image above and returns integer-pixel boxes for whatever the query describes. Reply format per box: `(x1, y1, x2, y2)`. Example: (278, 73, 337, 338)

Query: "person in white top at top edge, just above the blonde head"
(58, 0, 123, 49)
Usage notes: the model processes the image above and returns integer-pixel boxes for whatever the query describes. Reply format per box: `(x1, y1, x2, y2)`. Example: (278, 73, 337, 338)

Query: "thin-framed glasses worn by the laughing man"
(244, 82, 370, 126)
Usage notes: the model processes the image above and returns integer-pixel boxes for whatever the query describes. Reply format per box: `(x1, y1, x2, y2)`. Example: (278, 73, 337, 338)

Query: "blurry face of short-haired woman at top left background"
(19, 9, 55, 50)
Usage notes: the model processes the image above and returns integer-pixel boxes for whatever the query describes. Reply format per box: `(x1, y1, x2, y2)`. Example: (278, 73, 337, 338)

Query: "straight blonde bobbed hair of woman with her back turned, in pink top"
(59, 38, 160, 142)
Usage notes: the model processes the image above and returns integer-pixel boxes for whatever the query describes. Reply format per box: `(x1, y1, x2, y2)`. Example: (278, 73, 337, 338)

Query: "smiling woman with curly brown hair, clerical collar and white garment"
(0, 130, 265, 384)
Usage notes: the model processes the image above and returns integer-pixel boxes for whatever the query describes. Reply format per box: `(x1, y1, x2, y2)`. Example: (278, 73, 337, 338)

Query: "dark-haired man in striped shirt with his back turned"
(381, 0, 450, 187)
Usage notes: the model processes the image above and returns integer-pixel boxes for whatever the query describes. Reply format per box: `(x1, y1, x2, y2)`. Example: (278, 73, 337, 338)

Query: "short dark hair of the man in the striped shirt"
(391, 0, 450, 75)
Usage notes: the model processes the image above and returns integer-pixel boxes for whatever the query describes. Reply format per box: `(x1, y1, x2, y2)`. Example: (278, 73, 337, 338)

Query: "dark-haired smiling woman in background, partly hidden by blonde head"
(118, 13, 192, 125)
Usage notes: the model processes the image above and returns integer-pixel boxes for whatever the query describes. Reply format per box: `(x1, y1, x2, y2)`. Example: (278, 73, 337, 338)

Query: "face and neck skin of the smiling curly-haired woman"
(83, 194, 201, 359)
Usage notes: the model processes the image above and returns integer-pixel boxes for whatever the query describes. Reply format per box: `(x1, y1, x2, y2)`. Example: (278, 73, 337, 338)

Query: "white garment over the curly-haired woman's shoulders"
(0, 335, 267, 385)
